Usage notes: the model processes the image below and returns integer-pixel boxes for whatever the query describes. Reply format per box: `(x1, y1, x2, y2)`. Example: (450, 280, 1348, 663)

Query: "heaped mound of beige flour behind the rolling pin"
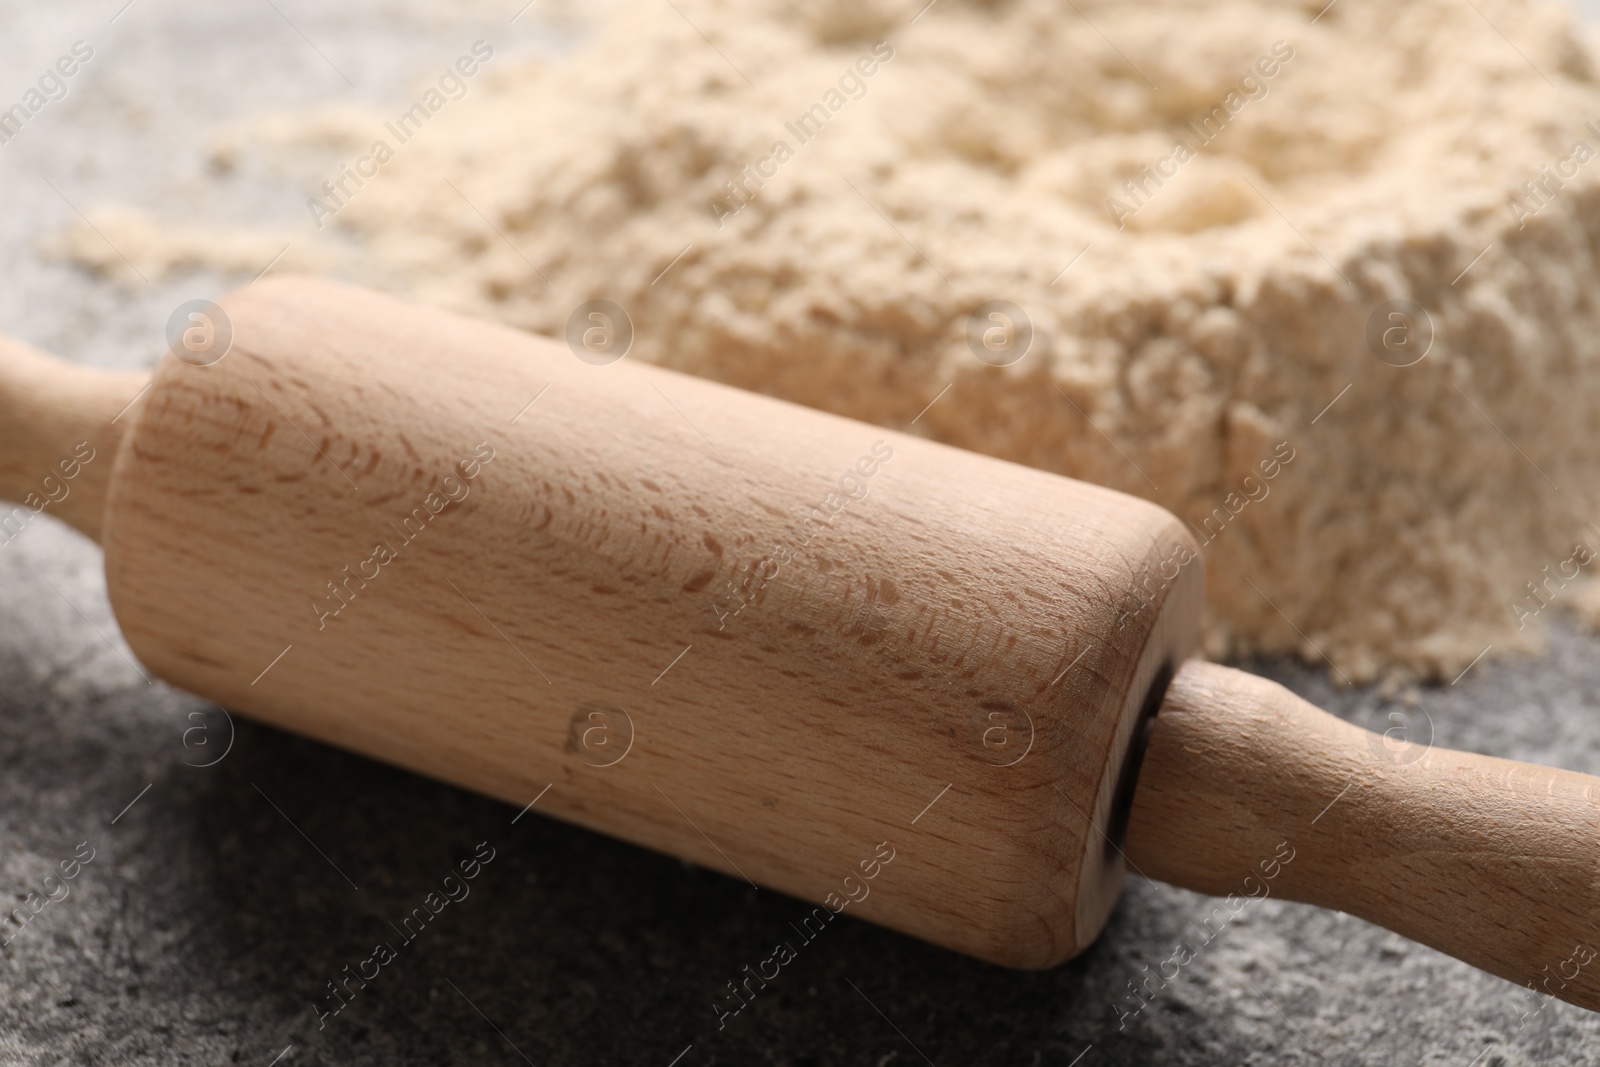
(72, 0, 1600, 678)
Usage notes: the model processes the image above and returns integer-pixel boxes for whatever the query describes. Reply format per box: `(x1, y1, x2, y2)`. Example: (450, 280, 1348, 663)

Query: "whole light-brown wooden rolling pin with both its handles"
(0, 278, 1600, 1008)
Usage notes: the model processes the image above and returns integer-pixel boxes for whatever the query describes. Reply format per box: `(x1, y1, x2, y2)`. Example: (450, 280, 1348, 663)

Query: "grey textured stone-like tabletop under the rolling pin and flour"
(0, 0, 1600, 1067)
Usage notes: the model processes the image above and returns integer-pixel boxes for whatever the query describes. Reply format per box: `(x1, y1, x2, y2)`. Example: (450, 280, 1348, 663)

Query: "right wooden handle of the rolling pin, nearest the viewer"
(1126, 662, 1600, 1009)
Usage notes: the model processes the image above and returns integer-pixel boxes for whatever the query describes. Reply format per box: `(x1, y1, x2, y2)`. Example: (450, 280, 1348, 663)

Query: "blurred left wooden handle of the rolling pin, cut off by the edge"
(0, 338, 149, 544)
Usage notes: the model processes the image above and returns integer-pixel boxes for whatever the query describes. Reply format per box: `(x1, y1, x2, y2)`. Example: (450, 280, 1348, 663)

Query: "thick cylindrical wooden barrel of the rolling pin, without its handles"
(104, 278, 1202, 966)
